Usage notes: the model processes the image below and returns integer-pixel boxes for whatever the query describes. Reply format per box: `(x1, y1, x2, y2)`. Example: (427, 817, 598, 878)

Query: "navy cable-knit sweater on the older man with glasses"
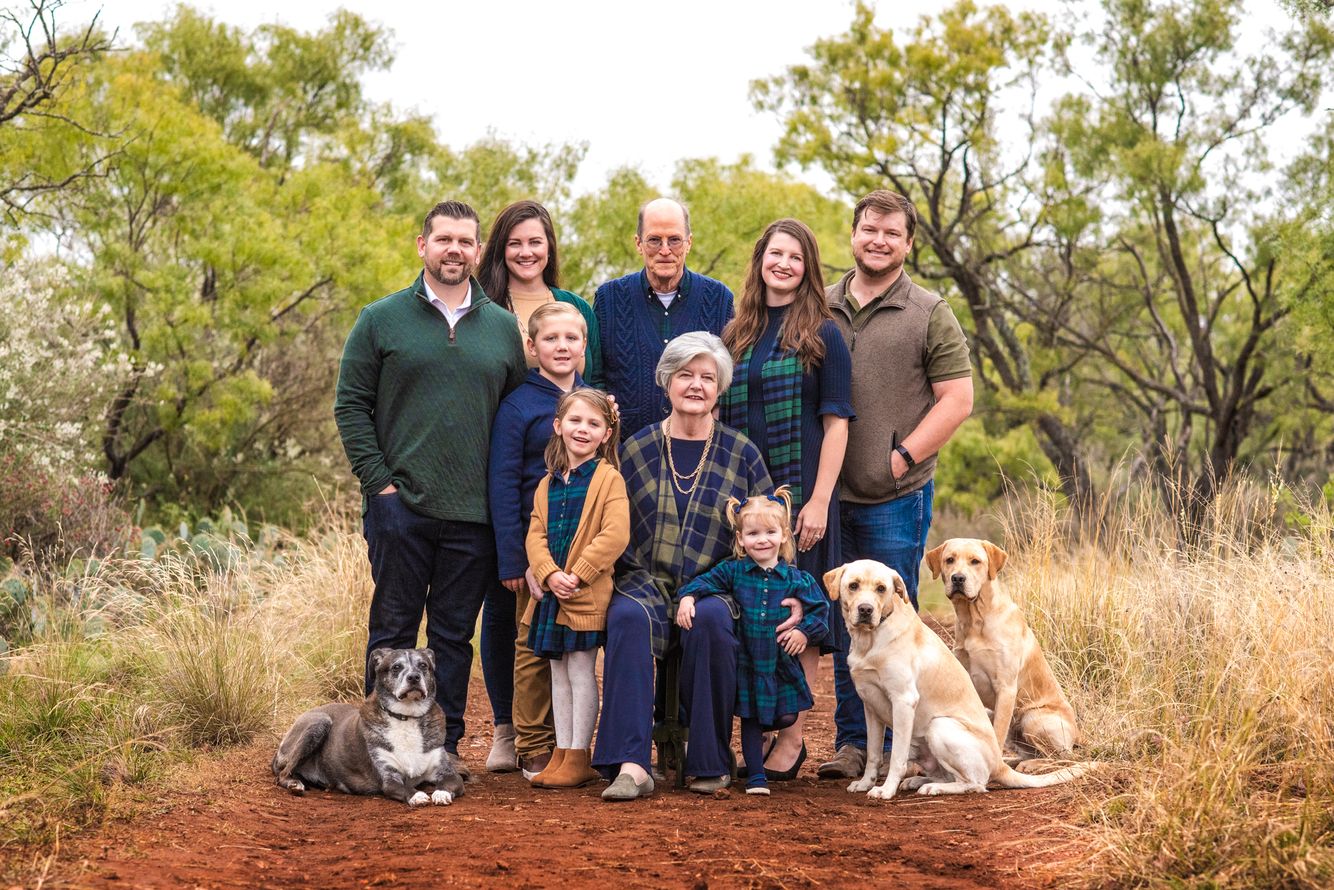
(592, 270, 734, 440)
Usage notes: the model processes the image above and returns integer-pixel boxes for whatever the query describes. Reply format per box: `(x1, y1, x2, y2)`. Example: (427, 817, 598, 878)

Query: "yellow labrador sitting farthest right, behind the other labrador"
(926, 538, 1083, 757)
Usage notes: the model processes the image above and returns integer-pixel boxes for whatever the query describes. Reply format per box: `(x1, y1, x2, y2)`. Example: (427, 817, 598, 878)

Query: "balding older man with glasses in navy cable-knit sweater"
(592, 197, 732, 439)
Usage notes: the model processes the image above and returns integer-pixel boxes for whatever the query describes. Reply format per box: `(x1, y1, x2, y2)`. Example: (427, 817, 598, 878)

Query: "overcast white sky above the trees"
(78, 0, 1307, 192)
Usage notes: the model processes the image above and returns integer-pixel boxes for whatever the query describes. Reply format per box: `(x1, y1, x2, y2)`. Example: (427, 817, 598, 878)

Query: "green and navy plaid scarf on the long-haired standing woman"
(720, 340, 806, 515)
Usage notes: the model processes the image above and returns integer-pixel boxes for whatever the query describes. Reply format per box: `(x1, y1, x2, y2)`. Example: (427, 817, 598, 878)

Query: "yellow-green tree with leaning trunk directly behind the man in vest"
(752, 0, 1091, 500)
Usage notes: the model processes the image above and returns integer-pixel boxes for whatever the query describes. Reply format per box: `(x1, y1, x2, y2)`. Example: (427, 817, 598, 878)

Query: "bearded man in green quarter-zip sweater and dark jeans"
(334, 201, 527, 778)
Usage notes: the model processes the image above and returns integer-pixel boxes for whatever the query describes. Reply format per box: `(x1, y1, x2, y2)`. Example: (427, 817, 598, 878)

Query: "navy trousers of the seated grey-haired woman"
(592, 594, 740, 778)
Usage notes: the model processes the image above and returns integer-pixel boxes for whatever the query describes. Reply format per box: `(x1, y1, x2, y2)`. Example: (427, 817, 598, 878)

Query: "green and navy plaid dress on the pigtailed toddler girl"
(678, 556, 830, 729)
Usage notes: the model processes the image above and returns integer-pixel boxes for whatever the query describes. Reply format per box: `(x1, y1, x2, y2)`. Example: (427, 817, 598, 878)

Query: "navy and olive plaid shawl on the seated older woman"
(616, 423, 774, 658)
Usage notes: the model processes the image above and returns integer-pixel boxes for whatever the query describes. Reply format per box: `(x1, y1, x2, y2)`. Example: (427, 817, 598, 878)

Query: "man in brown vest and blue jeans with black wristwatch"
(819, 189, 972, 778)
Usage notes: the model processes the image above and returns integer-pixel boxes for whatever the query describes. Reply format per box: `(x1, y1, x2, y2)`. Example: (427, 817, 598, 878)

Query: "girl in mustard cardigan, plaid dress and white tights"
(524, 390, 630, 789)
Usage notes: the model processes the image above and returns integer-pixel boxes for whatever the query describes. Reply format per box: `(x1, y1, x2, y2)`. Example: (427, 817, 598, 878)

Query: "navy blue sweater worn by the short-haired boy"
(487, 368, 584, 580)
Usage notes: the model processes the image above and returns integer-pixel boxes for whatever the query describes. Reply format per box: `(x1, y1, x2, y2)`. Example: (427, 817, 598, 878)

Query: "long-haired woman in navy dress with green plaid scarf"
(719, 219, 852, 779)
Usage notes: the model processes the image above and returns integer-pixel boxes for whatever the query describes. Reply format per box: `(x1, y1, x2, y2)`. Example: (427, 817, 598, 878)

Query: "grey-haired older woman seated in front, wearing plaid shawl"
(594, 331, 772, 801)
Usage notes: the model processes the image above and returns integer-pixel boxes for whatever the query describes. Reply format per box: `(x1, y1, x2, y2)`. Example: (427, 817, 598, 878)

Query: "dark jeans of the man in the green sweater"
(362, 494, 496, 754)
